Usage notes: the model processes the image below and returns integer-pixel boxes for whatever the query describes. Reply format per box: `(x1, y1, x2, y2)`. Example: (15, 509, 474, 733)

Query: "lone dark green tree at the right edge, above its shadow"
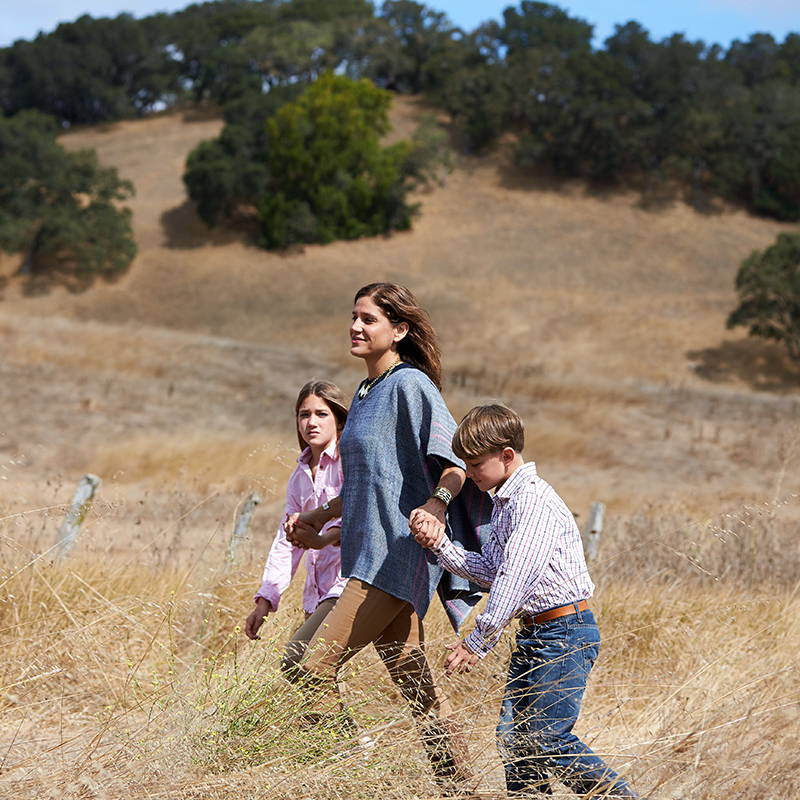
(728, 233, 800, 360)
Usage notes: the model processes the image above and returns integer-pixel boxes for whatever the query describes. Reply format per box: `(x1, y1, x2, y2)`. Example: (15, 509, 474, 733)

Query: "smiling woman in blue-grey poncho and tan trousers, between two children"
(286, 283, 490, 787)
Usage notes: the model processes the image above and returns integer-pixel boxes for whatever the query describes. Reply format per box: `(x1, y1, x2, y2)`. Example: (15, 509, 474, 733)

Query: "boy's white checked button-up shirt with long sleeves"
(434, 461, 594, 657)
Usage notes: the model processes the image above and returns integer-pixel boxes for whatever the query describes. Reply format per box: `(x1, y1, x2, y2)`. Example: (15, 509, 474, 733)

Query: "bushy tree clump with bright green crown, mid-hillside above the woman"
(183, 75, 452, 241)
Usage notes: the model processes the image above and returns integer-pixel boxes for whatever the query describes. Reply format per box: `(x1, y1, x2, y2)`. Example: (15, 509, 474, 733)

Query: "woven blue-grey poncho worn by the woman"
(339, 364, 491, 631)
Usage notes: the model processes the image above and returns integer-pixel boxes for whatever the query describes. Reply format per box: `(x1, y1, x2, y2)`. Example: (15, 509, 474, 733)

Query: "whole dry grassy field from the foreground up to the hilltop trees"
(0, 100, 800, 800)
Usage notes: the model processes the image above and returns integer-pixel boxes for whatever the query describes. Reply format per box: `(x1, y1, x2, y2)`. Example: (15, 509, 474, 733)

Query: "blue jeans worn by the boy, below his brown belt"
(497, 611, 637, 798)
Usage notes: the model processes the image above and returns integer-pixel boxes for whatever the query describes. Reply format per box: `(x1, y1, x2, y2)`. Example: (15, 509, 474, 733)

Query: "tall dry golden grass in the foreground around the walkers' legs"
(0, 500, 800, 800)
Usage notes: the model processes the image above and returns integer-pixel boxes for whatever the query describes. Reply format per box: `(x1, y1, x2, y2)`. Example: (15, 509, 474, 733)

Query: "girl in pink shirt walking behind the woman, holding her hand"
(244, 381, 347, 678)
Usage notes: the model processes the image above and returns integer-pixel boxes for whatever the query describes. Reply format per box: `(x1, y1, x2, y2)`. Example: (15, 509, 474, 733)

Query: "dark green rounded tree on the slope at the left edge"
(0, 111, 136, 277)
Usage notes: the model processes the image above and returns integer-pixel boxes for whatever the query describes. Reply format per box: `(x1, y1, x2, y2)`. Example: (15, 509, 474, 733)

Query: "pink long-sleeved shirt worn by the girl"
(254, 443, 347, 614)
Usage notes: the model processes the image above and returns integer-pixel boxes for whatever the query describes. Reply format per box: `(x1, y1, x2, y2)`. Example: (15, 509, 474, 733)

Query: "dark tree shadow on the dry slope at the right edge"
(686, 339, 800, 392)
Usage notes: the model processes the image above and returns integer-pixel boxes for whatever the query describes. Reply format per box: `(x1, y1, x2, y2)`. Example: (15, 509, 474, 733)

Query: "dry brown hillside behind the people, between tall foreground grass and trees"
(0, 95, 800, 510)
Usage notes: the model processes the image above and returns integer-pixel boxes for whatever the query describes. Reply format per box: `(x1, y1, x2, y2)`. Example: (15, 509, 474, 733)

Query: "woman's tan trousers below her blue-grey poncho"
(300, 578, 472, 783)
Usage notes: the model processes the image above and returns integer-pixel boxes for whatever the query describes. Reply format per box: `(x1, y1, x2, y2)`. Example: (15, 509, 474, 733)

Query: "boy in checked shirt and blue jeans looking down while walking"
(411, 405, 637, 798)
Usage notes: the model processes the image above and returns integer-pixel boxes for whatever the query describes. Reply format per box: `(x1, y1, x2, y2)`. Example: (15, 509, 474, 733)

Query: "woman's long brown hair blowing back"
(353, 283, 442, 390)
